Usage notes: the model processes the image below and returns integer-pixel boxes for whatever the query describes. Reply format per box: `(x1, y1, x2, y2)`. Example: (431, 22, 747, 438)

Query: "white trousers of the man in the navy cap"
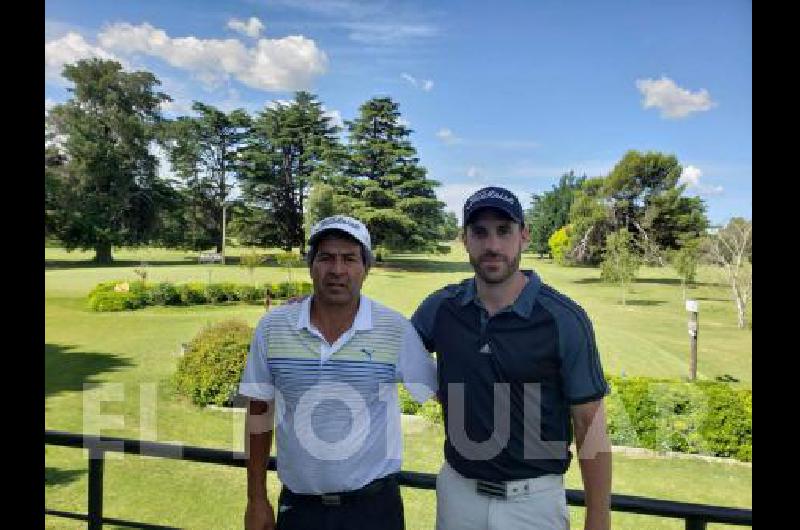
(436, 462, 569, 530)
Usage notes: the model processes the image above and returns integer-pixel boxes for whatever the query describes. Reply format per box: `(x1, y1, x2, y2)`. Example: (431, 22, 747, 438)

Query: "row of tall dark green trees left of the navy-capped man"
(45, 59, 458, 263)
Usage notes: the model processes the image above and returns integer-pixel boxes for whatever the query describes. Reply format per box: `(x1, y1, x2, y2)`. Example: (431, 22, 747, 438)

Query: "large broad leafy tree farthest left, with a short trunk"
(45, 59, 169, 263)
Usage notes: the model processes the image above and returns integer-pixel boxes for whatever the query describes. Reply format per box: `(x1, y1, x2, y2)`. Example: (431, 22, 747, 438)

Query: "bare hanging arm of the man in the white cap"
(245, 399, 275, 530)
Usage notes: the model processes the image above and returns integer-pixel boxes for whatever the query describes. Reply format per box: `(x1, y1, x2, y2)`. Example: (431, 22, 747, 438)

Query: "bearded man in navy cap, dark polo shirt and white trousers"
(411, 187, 611, 530)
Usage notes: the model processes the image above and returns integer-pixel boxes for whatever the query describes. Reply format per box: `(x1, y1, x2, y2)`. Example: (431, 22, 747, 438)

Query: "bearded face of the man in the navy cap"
(464, 208, 530, 283)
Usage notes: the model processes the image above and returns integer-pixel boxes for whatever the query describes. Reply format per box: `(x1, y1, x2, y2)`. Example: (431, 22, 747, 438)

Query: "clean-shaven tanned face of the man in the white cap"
(311, 237, 367, 305)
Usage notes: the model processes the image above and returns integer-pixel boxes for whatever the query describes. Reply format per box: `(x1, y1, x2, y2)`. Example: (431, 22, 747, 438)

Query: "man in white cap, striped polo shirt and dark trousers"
(239, 215, 436, 530)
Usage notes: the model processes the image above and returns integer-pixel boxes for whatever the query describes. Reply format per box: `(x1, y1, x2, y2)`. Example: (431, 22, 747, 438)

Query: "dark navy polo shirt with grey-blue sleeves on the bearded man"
(411, 271, 609, 481)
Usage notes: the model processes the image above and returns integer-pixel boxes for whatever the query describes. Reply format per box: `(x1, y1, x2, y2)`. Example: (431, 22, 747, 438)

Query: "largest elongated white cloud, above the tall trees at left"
(99, 23, 328, 90)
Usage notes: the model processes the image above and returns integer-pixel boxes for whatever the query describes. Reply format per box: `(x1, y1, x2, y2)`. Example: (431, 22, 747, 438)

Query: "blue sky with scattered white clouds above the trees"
(45, 0, 752, 223)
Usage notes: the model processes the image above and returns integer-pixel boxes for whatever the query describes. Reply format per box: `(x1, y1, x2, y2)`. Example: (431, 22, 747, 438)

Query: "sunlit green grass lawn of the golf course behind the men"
(45, 246, 752, 529)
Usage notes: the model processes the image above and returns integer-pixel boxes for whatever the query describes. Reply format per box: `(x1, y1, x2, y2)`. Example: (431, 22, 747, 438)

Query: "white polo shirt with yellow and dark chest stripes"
(239, 295, 436, 494)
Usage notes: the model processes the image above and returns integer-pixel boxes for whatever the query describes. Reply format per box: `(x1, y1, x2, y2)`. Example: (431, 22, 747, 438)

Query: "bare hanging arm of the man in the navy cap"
(571, 399, 611, 530)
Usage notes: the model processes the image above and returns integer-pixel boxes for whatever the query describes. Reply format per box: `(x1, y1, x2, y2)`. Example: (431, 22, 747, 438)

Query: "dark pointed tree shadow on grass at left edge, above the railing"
(44, 344, 133, 399)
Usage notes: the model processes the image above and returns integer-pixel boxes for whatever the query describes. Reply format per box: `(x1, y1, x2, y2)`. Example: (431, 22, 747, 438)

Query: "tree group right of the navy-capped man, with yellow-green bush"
(526, 150, 753, 328)
